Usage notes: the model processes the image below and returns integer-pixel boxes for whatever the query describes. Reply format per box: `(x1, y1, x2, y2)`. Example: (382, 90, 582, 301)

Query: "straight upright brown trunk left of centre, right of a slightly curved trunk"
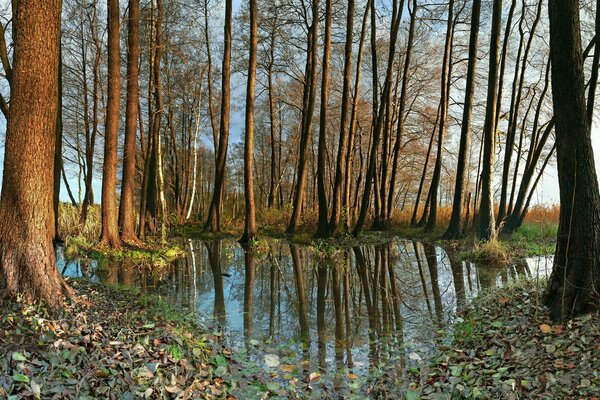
(240, 0, 258, 243)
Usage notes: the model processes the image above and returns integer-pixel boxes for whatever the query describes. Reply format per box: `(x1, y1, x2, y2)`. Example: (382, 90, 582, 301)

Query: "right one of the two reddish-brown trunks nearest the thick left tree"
(119, 0, 140, 242)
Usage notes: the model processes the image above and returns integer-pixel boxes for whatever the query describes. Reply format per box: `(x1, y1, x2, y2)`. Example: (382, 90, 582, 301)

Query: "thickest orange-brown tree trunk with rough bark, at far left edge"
(0, 0, 69, 306)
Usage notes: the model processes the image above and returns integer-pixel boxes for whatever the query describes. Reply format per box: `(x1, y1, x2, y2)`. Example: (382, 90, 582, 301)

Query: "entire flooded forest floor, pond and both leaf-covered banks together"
(0, 220, 600, 399)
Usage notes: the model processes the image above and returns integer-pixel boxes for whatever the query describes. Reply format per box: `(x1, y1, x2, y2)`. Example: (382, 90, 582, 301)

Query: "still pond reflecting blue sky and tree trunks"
(58, 239, 552, 398)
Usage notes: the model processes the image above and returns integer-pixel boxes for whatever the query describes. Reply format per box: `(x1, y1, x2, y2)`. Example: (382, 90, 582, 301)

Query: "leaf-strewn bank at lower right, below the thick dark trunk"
(372, 281, 600, 400)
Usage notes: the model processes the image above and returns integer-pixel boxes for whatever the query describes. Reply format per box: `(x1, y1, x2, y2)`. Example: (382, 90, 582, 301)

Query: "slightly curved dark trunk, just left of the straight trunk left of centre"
(204, 0, 232, 233)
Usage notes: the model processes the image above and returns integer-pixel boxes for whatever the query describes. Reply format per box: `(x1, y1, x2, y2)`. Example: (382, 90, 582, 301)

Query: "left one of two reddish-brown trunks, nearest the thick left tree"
(100, 0, 121, 248)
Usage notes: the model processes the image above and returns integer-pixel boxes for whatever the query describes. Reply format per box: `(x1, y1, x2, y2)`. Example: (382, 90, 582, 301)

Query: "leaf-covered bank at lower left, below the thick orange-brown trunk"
(0, 280, 234, 399)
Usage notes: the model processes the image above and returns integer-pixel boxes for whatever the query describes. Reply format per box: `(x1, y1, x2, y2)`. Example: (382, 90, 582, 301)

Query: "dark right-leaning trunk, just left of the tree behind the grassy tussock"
(444, 0, 481, 239)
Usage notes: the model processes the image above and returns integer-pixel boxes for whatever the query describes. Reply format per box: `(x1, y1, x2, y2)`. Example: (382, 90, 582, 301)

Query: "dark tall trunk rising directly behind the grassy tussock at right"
(479, 0, 502, 240)
